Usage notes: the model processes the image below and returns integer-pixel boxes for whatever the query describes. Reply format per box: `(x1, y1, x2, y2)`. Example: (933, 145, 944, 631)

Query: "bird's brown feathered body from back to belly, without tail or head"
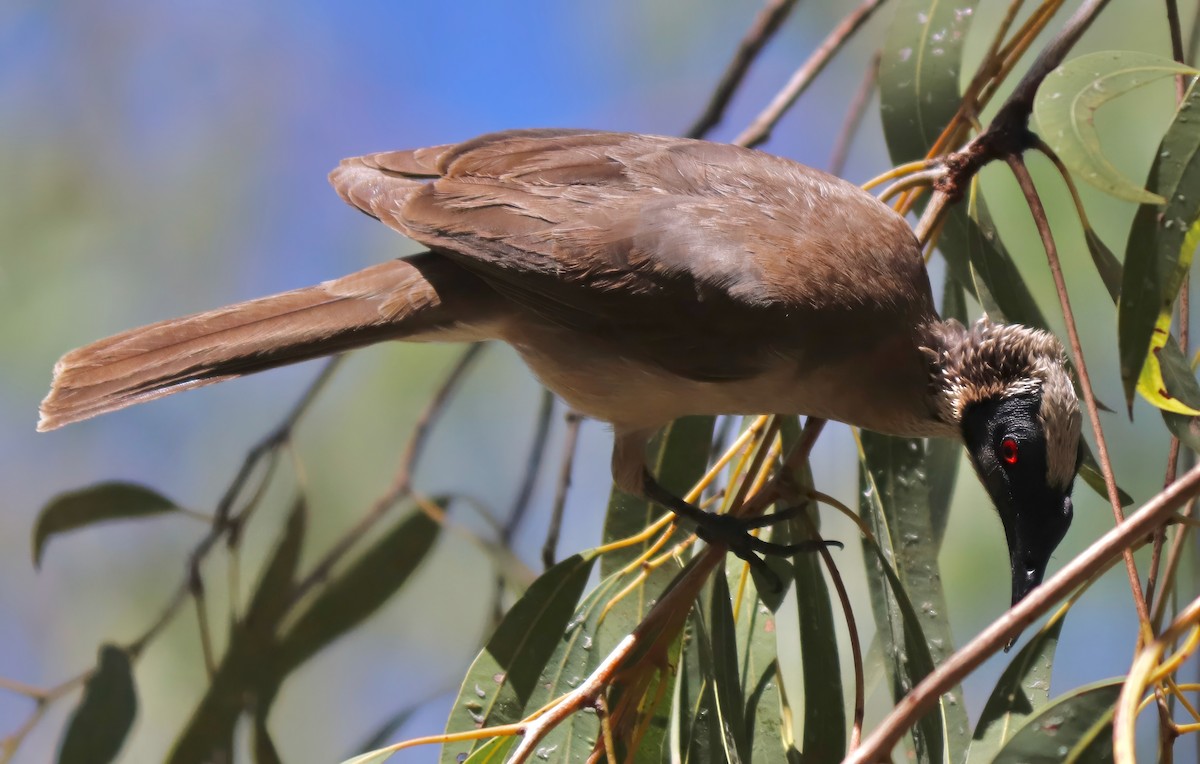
(330, 130, 936, 432)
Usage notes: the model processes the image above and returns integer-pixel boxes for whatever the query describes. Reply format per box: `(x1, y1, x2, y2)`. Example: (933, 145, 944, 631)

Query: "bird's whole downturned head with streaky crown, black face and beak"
(931, 319, 1081, 604)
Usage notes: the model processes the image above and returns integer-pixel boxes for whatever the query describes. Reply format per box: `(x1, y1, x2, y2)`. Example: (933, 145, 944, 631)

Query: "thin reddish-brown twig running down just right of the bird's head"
(1008, 154, 1150, 628)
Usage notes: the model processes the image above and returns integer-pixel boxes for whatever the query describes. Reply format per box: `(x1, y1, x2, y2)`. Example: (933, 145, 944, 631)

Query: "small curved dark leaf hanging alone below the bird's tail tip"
(34, 482, 180, 567)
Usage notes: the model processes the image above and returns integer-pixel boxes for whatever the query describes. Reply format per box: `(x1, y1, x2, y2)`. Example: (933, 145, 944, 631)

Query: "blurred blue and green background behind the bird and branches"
(0, 0, 1193, 763)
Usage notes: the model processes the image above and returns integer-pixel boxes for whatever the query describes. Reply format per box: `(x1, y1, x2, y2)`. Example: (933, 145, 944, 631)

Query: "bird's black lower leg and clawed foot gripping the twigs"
(642, 468, 842, 565)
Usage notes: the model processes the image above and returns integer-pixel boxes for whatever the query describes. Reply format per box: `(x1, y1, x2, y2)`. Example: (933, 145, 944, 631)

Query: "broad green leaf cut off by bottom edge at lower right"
(992, 679, 1122, 764)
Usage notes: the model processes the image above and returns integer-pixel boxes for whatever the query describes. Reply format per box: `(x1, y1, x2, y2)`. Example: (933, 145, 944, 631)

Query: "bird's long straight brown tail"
(37, 253, 494, 431)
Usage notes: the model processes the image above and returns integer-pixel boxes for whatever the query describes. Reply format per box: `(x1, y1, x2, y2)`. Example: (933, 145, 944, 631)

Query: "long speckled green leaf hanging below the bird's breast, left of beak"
(859, 432, 970, 762)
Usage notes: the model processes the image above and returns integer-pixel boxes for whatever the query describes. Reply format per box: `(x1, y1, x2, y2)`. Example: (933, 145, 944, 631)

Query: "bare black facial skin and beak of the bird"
(962, 393, 1072, 604)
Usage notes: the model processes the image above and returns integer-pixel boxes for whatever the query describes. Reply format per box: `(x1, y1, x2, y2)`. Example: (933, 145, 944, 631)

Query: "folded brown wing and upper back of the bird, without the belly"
(330, 130, 932, 379)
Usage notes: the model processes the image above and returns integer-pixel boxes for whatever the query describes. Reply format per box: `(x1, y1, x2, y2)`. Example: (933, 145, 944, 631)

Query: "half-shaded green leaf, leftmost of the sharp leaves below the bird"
(440, 554, 595, 763)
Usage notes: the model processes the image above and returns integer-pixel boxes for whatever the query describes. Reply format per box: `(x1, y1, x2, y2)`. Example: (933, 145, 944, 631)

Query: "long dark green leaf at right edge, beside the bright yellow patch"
(1117, 82, 1200, 405)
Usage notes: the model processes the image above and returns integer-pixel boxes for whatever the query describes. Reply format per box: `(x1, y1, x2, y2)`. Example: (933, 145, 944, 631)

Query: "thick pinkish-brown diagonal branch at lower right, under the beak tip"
(845, 458, 1200, 764)
